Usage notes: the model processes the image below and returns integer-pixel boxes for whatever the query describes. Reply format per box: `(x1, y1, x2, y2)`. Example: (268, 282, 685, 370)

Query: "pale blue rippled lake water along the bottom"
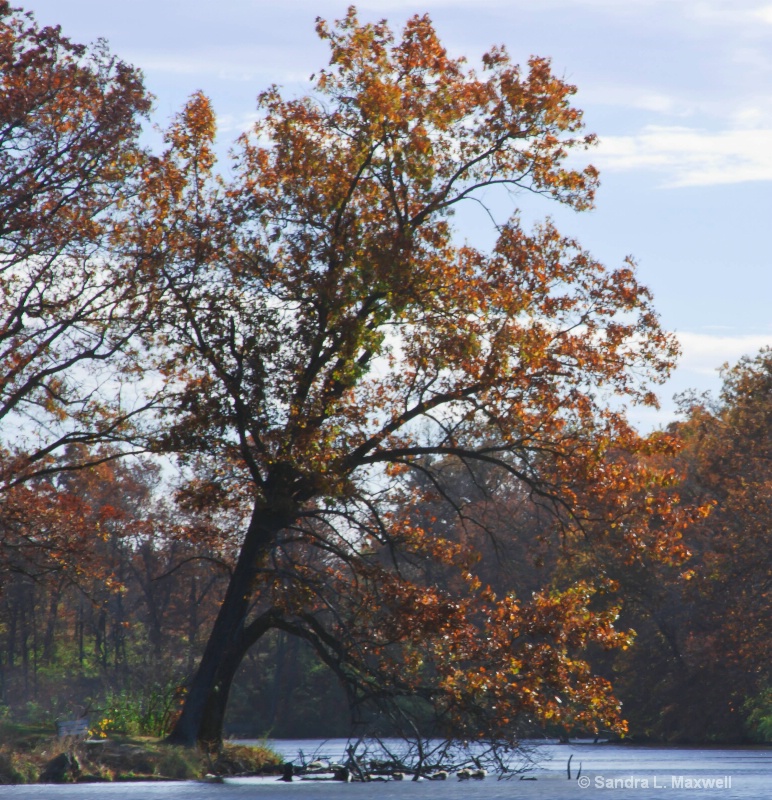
(0, 739, 772, 800)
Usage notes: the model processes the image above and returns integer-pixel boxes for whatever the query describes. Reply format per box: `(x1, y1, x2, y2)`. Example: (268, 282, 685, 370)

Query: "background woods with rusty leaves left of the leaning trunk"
(0, 445, 232, 735)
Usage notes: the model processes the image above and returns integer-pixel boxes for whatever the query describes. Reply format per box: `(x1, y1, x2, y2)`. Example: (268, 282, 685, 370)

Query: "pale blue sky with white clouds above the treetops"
(19, 0, 772, 429)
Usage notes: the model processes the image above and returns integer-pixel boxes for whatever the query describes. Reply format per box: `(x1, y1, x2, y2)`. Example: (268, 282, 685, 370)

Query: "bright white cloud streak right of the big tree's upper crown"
(594, 125, 772, 187)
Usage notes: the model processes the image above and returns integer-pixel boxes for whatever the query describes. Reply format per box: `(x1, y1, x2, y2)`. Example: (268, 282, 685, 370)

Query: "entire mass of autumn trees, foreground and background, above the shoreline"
(0, 0, 772, 749)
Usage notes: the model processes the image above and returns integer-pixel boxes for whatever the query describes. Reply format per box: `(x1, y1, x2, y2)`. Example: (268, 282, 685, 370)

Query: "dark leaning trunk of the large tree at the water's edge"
(167, 508, 294, 747)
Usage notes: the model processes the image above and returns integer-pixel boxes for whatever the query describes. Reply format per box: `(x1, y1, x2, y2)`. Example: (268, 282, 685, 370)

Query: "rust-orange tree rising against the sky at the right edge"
(681, 348, 772, 688)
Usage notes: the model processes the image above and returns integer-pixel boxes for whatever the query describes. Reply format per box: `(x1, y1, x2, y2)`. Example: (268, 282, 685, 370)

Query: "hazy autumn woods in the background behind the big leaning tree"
(0, 351, 772, 742)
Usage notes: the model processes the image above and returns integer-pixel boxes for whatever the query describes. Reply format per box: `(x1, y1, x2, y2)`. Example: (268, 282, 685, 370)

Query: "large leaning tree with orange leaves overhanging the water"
(123, 9, 688, 745)
